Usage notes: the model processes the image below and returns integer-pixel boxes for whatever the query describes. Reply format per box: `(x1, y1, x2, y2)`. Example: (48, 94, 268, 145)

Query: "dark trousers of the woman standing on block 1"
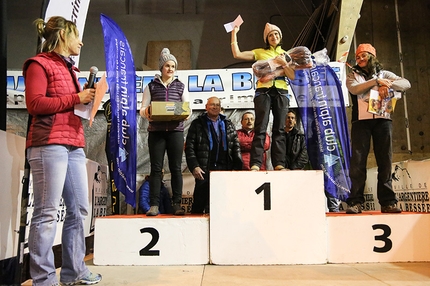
(249, 88, 290, 168)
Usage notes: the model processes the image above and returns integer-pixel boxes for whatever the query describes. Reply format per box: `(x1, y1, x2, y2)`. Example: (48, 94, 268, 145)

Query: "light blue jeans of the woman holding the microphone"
(27, 145, 90, 285)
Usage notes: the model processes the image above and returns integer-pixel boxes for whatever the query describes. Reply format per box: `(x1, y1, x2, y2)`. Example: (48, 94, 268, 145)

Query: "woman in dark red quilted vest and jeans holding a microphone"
(23, 16, 102, 286)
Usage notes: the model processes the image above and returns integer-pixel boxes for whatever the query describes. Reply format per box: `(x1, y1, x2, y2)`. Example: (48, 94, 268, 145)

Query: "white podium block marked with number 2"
(94, 215, 209, 265)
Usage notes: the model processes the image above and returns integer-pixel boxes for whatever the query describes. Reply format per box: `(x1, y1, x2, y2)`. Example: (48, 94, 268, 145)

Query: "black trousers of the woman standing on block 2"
(148, 131, 184, 206)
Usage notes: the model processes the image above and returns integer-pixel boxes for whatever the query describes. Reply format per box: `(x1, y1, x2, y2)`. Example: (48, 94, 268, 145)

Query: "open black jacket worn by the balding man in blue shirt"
(185, 113, 242, 172)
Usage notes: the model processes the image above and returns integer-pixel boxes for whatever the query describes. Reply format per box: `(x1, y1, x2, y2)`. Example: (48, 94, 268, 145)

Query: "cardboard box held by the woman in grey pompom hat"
(151, 101, 190, 121)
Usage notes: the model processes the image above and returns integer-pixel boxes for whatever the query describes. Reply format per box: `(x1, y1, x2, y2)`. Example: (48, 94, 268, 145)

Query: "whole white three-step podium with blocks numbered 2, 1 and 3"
(94, 170, 430, 265)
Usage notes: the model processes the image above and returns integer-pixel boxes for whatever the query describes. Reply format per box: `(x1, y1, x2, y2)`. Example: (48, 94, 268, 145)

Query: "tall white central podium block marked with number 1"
(210, 171, 327, 265)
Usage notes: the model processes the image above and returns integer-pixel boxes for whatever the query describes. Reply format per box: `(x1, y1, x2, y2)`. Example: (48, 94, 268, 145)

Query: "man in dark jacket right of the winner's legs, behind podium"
(284, 110, 309, 170)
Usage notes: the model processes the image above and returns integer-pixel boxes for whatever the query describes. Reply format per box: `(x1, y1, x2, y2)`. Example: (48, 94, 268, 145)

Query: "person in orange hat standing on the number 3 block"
(346, 43, 411, 214)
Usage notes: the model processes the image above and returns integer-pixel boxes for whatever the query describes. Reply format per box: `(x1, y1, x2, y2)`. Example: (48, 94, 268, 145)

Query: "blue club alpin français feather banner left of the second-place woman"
(100, 14, 137, 207)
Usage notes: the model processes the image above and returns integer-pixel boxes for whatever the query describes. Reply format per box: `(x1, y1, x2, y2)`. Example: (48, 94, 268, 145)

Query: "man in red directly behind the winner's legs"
(237, 111, 270, 171)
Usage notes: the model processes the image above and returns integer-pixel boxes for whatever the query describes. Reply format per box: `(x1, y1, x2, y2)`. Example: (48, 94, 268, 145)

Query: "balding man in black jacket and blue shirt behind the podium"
(185, 97, 242, 213)
